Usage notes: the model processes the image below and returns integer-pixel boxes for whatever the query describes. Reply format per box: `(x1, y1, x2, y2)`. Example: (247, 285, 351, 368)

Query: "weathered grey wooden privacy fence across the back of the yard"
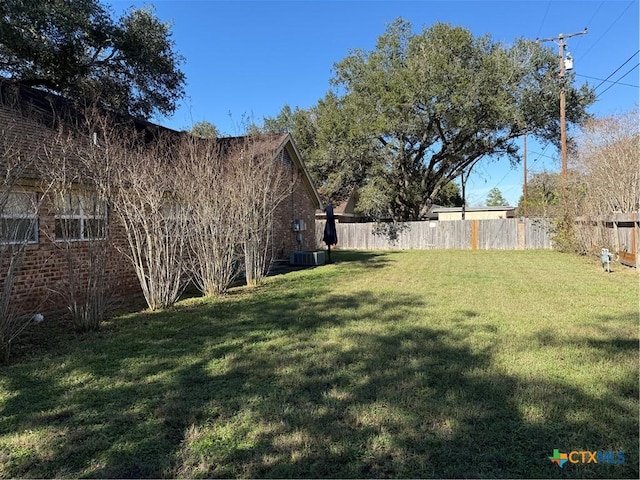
(316, 218, 552, 250)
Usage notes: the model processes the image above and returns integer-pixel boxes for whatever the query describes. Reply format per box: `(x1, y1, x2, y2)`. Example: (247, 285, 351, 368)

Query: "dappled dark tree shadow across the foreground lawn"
(0, 252, 638, 478)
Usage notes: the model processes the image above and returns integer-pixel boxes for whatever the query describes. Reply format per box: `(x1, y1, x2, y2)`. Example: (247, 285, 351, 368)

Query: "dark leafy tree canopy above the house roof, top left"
(0, 0, 185, 118)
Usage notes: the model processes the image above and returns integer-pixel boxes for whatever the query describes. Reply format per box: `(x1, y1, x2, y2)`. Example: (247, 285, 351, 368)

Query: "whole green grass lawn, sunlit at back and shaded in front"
(0, 251, 640, 478)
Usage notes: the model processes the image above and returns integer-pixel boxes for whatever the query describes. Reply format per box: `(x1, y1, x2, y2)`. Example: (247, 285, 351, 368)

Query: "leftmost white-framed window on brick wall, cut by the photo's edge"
(0, 191, 38, 244)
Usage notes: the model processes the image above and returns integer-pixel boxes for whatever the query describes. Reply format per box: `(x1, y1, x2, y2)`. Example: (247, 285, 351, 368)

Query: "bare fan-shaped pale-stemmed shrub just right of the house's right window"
(104, 125, 190, 310)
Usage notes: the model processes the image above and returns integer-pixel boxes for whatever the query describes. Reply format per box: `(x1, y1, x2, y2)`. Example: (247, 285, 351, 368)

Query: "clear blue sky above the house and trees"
(105, 0, 640, 205)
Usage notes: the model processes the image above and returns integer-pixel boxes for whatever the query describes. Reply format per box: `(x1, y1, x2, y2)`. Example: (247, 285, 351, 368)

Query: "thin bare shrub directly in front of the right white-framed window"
(40, 116, 113, 331)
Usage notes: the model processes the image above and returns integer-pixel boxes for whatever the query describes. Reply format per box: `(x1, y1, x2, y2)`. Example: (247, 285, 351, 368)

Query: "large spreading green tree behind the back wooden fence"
(266, 19, 594, 220)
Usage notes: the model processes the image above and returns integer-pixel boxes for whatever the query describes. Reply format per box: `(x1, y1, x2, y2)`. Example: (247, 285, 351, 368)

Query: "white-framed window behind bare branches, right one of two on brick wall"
(55, 190, 107, 241)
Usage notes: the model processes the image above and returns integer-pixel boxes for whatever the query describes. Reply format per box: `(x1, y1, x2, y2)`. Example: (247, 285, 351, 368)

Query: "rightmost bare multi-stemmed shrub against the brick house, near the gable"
(229, 135, 295, 285)
